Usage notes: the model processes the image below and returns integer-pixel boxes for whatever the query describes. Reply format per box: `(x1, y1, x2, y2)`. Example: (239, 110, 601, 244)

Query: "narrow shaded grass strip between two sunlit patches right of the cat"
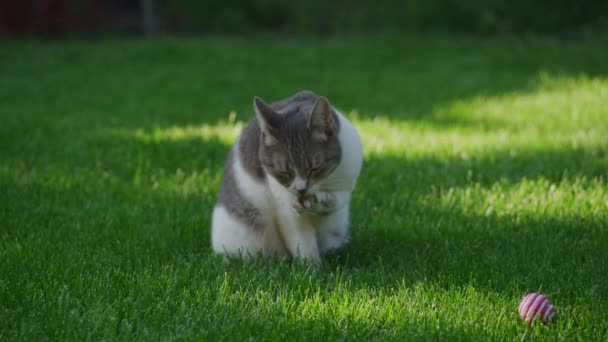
(360, 145, 608, 195)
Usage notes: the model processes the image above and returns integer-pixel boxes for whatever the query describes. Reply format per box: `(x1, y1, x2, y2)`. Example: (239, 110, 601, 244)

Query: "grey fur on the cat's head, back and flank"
(218, 91, 342, 229)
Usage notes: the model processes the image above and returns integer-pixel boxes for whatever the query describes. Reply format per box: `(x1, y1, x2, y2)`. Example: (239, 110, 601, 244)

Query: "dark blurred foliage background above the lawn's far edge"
(0, 0, 608, 38)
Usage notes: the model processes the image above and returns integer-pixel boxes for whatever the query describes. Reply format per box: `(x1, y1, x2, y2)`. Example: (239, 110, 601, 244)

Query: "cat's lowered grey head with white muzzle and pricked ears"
(253, 97, 342, 196)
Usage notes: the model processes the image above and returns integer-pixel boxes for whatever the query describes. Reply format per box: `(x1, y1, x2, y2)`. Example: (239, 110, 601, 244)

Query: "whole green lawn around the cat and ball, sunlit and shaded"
(0, 37, 608, 341)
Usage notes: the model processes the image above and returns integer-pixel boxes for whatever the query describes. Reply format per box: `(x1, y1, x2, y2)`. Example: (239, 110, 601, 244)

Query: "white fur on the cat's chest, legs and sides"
(211, 113, 363, 262)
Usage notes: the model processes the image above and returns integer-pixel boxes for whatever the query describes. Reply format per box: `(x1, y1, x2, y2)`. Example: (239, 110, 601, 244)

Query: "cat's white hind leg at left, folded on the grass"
(211, 205, 264, 259)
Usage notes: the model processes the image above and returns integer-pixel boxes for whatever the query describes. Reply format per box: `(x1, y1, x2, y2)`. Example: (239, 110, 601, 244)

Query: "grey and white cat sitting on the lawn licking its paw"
(211, 91, 363, 263)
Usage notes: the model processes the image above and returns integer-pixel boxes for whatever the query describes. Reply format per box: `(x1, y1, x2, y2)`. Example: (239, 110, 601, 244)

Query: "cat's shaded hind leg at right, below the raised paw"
(317, 205, 349, 255)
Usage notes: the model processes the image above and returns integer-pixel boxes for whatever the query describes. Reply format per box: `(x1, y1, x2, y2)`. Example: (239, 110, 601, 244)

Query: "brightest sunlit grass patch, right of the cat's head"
(350, 74, 608, 153)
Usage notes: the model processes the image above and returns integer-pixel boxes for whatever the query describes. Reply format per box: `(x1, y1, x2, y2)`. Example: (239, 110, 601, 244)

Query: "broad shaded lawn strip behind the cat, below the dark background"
(3, 35, 608, 132)
